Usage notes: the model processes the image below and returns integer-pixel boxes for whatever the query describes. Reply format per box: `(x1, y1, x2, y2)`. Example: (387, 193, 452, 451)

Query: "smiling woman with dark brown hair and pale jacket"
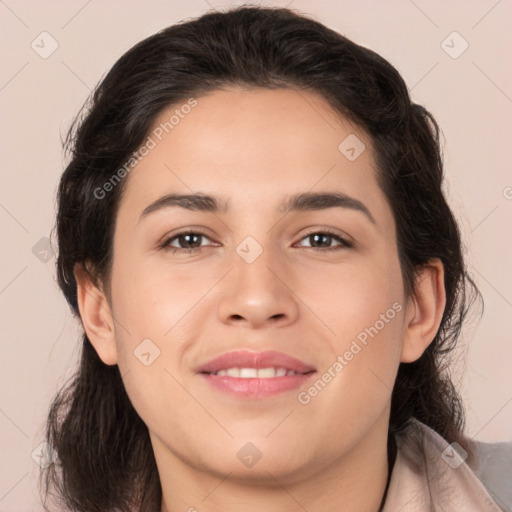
(43, 7, 506, 512)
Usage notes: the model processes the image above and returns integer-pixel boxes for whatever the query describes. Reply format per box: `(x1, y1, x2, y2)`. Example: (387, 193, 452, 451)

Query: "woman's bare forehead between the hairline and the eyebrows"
(120, 88, 392, 230)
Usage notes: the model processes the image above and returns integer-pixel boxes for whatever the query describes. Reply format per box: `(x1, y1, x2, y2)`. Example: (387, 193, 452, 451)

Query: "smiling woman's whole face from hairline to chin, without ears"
(103, 88, 406, 484)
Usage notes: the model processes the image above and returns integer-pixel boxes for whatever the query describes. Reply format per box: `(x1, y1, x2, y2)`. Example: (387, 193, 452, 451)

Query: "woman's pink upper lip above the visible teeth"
(197, 350, 315, 373)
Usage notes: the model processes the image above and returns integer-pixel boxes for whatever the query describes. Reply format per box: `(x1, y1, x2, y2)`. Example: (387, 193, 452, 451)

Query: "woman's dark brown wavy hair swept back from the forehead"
(42, 7, 481, 512)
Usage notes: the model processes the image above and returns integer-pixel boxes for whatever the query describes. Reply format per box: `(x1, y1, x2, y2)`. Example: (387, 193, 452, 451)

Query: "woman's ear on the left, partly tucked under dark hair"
(74, 263, 117, 365)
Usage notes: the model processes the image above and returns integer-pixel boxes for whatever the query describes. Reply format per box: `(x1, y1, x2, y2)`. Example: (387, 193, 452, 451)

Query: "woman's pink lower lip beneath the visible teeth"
(200, 372, 315, 398)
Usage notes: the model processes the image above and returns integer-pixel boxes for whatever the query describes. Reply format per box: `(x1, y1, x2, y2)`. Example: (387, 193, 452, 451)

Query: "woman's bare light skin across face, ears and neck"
(75, 88, 445, 512)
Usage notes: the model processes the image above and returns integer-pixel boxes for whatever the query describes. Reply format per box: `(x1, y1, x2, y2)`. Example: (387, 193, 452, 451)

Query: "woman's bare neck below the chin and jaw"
(155, 418, 394, 512)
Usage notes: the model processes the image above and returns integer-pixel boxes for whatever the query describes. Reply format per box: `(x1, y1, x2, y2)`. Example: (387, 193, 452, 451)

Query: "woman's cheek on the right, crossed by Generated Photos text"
(311, 243, 405, 396)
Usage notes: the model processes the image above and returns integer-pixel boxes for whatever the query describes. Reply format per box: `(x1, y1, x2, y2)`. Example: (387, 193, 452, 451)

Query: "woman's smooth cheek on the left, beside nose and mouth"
(112, 259, 204, 444)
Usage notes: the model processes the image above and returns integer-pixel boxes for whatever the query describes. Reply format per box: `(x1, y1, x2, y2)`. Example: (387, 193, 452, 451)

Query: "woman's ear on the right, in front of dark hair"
(400, 258, 446, 363)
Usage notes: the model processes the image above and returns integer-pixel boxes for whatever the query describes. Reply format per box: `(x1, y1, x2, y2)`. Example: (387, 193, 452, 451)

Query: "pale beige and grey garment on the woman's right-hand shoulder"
(382, 420, 512, 512)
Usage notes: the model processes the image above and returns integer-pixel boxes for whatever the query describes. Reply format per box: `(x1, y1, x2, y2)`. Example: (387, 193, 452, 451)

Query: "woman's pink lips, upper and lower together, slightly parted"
(198, 350, 316, 399)
